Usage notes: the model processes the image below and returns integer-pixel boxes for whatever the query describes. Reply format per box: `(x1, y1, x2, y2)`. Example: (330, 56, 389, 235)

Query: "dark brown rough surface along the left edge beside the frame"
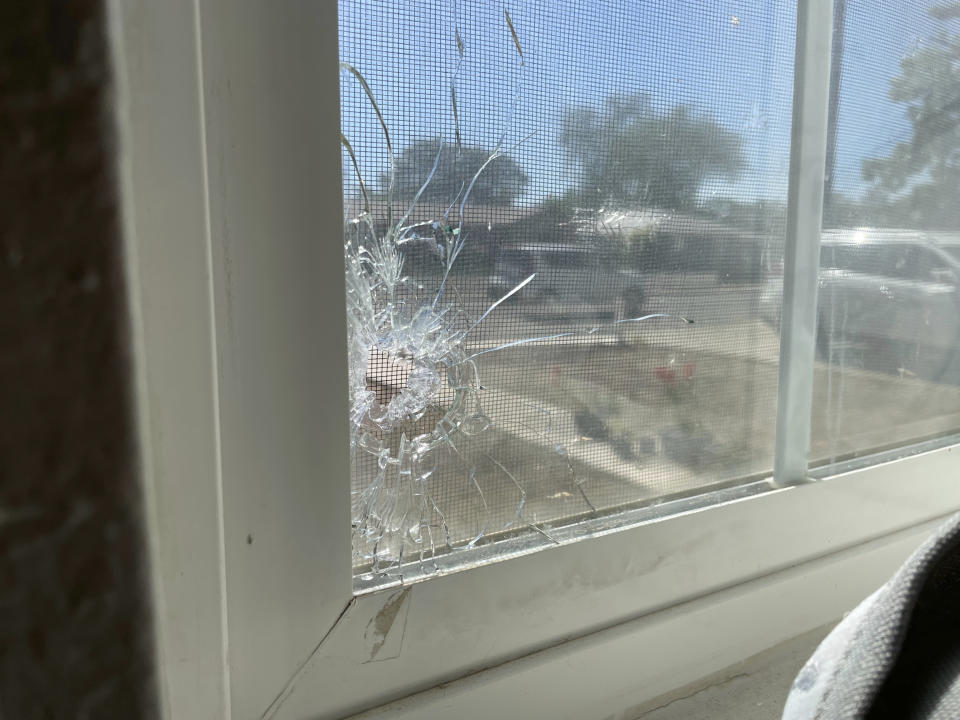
(0, 0, 155, 720)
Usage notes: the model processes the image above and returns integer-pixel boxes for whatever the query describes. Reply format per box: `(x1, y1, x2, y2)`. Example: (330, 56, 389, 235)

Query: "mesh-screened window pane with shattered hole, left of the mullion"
(340, 0, 795, 573)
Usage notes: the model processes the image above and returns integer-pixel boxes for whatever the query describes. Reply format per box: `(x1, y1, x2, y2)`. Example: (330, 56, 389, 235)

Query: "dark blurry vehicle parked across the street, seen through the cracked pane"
(487, 243, 646, 321)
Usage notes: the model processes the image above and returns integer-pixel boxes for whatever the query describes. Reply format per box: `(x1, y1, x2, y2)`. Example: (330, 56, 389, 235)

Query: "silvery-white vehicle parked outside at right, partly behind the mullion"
(761, 230, 960, 379)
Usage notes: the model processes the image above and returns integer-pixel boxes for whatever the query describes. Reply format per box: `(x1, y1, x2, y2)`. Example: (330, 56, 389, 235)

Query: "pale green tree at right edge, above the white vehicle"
(862, 2, 960, 228)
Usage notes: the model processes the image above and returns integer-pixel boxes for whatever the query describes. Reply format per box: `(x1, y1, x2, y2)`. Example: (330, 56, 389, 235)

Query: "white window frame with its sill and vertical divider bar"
(110, 0, 960, 719)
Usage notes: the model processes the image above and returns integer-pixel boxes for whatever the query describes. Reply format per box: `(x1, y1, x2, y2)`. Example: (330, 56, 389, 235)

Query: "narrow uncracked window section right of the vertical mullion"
(811, 0, 960, 464)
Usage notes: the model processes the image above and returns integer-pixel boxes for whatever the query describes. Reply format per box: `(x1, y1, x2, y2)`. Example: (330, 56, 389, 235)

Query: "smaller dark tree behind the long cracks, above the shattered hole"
(380, 140, 529, 205)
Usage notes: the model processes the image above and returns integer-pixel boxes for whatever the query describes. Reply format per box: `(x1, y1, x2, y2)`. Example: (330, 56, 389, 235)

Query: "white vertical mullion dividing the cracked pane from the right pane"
(773, 0, 833, 485)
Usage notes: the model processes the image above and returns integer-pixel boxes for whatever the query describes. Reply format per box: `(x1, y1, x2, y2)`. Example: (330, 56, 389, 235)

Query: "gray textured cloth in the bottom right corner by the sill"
(783, 514, 960, 720)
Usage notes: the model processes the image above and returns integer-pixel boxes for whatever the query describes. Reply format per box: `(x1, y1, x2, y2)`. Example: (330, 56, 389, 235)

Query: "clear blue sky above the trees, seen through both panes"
(340, 0, 952, 208)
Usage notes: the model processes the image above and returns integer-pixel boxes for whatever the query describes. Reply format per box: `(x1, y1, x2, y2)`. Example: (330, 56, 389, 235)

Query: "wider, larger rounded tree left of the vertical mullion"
(560, 93, 743, 210)
